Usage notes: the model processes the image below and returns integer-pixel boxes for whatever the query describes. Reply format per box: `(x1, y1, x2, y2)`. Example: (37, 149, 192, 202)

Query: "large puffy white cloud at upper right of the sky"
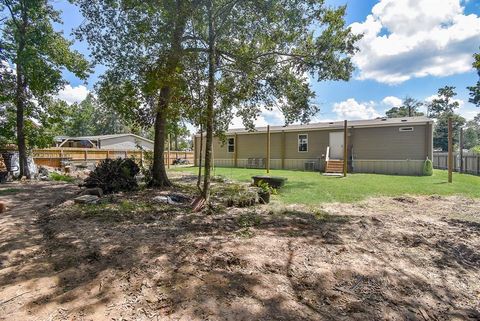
(352, 0, 480, 84)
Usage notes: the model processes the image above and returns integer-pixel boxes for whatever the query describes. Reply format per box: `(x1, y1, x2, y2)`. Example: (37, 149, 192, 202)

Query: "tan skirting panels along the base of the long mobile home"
(196, 158, 425, 175)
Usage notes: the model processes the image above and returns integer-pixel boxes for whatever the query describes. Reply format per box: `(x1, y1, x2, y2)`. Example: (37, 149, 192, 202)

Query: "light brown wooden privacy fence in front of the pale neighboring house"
(33, 147, 193, 168)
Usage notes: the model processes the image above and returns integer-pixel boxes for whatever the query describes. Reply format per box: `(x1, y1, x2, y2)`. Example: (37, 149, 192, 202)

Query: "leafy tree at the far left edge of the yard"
(0, 0, 89, 177)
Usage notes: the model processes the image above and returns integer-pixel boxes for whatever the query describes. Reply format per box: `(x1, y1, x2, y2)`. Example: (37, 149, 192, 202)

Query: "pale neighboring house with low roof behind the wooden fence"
(55, 134, 153, 150)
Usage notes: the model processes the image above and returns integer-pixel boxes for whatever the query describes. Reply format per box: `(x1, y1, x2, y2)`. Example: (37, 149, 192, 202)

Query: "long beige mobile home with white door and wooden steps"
(194, 117, 433, 175)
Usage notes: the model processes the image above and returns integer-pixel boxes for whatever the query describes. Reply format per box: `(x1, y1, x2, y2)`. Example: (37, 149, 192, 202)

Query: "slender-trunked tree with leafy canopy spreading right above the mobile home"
(194, 0, 360, 202)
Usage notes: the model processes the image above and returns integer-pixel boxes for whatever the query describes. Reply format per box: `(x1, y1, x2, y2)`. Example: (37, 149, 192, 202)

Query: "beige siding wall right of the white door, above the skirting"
(351, 125, 427, 160)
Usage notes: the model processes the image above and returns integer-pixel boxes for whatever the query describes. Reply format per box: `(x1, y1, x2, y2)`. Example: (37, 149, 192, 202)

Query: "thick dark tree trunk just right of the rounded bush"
(150, 87, 172, 187)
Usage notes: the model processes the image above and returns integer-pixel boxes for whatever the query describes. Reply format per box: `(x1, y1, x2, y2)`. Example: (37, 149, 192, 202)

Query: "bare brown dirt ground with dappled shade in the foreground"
(0, 182, 480, 321)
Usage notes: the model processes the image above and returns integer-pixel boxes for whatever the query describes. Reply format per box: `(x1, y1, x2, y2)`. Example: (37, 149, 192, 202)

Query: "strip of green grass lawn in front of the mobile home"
(171, 167, 480, 204)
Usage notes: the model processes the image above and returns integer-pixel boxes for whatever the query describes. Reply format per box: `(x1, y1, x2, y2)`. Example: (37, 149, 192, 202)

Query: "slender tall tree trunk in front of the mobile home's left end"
(202, 1, 215, 204)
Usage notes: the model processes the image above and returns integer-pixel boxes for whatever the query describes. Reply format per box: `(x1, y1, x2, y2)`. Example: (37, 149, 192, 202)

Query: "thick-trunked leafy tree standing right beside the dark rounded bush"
(74, 0, 198, 186)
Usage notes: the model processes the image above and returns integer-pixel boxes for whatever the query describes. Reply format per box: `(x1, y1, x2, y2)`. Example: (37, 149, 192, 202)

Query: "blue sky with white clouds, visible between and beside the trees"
(55, 0, 480, 127)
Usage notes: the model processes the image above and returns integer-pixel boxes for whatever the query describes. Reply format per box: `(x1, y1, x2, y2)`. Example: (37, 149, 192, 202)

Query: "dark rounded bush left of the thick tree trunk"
(83, 158, 140, 194)
